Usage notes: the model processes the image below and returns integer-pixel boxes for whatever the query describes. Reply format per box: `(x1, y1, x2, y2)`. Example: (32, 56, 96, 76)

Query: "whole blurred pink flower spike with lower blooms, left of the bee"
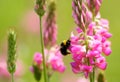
(31, 0, 65, 76)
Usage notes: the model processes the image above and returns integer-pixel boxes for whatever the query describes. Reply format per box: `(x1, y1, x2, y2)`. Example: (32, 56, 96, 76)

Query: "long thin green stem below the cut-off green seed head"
(39, 16, 48, 82)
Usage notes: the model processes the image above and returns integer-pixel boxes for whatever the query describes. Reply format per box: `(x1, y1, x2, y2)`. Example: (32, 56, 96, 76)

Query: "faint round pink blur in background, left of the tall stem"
(21, 10, 39, 34)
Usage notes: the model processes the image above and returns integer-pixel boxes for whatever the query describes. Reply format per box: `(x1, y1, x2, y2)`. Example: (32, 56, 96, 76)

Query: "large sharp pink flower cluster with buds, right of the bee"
(69, 0, 112, 78)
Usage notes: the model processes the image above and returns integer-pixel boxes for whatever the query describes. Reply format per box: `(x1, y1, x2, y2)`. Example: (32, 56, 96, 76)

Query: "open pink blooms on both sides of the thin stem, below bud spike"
(31, 46, 65, 73)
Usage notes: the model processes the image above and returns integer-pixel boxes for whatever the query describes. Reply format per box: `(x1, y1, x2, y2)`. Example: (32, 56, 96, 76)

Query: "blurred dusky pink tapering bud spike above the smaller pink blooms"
(43, 1, 57, 47)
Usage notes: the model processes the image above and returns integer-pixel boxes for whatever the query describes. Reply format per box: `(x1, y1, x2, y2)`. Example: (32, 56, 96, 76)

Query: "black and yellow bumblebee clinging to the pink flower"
(60, 40, 71, 56)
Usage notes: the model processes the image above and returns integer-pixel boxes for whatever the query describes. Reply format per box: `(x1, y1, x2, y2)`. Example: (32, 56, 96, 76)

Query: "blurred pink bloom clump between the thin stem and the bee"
(47, 46, 65, 73)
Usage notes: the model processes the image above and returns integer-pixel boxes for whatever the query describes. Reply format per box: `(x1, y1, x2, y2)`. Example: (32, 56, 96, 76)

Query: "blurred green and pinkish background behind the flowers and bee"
(0, 0, 120, 82)
